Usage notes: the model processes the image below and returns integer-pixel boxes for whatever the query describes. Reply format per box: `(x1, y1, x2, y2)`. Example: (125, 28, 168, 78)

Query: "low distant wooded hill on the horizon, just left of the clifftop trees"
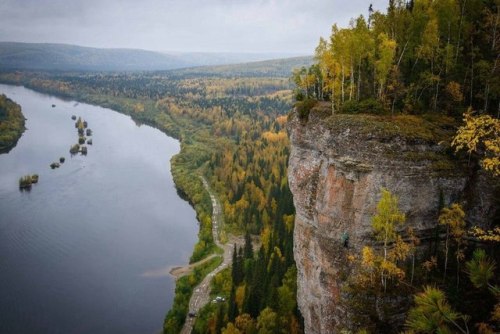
(171, 56, 314, 77)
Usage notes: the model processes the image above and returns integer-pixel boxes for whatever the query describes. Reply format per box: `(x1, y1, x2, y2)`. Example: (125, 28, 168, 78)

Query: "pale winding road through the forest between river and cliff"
(181, 176, 243, 334)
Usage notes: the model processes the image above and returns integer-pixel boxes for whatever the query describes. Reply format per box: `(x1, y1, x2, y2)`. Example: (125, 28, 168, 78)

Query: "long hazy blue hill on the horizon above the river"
(0, 42, 308, 71)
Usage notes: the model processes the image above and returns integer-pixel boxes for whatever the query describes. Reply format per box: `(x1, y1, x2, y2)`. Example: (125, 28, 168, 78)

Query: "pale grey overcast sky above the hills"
(0, 0, 387, 54)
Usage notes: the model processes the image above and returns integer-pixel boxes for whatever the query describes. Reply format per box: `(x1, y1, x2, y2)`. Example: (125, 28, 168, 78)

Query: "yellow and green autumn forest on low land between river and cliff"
(0, 63, 301, 333)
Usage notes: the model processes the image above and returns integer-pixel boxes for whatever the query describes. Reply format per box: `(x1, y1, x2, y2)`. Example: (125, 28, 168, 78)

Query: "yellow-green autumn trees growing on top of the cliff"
(292, 0, 500, 115)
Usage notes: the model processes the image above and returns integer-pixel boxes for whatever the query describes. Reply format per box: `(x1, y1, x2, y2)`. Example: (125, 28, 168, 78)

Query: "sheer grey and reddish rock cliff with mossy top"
(288, 103, 498, 333)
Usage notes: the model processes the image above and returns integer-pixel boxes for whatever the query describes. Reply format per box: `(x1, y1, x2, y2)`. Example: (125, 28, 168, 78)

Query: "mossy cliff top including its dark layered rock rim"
(290, 102, 467, 175)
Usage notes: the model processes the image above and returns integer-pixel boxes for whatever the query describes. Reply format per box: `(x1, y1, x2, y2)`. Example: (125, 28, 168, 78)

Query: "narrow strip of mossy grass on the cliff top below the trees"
(309, 102, 458, 145)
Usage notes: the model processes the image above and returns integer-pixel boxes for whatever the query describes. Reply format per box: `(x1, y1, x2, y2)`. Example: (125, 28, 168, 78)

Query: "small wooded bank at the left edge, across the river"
(0, 94, 26, 154)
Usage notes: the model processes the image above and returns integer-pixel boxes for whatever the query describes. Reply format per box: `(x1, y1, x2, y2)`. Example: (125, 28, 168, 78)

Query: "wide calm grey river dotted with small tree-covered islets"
(0, 85, 198, 333)
